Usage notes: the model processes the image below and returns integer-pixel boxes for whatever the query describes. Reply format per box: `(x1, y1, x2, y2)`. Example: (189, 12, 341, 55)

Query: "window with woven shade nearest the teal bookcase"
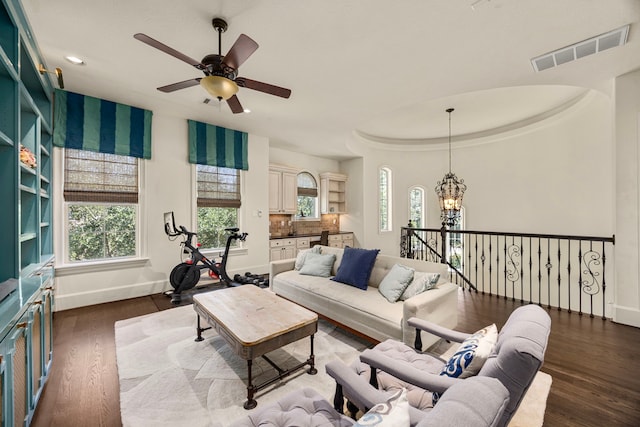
(64, 148, 138, 262)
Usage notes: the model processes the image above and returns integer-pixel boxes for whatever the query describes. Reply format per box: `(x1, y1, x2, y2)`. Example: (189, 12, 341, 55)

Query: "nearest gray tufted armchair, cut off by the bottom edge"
(231, 377, 509, 427)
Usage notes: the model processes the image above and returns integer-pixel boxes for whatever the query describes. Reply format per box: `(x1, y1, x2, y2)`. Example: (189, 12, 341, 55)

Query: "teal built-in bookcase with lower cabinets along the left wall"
(0, 0, 54, 427)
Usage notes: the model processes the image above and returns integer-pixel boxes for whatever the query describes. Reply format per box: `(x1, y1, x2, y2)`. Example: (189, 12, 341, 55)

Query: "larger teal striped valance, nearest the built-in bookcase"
(53, 89, 153, 159)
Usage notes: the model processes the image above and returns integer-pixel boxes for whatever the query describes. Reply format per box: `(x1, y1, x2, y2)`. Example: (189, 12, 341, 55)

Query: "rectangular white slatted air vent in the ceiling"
(531, 25, 629, 71)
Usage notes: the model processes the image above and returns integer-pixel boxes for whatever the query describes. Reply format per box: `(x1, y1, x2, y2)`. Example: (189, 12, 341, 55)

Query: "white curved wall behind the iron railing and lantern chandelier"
(343, 92, 614, 255)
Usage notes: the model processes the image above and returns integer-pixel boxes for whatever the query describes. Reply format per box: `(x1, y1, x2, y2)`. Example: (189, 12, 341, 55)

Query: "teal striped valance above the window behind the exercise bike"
(189, 120, 249, 170)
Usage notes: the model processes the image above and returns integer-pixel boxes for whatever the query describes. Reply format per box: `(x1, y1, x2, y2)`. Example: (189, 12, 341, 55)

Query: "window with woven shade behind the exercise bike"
(196, 165, 240, 249)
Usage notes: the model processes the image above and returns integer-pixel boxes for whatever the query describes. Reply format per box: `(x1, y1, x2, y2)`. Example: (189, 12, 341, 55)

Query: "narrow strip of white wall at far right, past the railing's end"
(613, 71, 640, 327)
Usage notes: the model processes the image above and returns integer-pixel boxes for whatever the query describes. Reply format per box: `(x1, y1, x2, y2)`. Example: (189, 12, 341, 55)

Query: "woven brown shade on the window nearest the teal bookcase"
(64, 148, 138, 203)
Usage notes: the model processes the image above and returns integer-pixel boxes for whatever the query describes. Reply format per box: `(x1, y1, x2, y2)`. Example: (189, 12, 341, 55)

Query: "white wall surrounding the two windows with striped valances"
(54, 113, 269, 310)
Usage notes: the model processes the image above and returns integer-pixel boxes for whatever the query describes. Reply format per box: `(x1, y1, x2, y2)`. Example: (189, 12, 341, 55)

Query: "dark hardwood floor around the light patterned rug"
(32, 292, 640, 427)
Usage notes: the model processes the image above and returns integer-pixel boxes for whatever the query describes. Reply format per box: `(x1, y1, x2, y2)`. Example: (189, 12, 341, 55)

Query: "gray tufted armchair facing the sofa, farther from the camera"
(327, 305, 551, 426)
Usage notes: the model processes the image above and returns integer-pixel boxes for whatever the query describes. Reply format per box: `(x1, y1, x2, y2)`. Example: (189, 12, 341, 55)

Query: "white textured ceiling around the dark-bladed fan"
(22, 0, 640, 159)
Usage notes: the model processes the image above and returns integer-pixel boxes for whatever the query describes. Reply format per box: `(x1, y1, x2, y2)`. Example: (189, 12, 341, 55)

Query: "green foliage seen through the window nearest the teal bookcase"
(68, 204, 136, 261)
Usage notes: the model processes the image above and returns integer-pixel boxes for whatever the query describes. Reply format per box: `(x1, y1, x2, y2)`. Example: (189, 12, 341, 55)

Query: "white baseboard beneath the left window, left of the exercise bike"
(54, 280, 171, 311)
